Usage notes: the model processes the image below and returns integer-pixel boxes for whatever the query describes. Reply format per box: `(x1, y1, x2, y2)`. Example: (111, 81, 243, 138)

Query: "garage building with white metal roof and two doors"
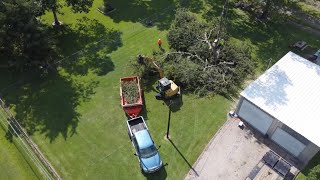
(235, 52, 320, 165)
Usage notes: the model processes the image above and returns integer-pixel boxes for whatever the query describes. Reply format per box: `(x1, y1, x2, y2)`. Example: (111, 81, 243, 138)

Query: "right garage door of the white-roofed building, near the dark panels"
(271, 128, 306, 157)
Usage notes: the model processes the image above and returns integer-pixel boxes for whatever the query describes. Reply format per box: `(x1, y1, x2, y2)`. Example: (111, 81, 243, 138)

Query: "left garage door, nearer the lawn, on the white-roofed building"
(238, 99, 273, 134)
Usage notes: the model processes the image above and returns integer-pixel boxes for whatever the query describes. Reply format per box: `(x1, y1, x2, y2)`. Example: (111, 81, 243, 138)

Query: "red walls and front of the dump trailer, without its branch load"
(120, 76, 143, 118)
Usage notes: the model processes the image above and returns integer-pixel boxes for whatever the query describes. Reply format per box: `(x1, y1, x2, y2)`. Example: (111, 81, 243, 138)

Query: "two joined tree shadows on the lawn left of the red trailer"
(1, 18, 122, 142)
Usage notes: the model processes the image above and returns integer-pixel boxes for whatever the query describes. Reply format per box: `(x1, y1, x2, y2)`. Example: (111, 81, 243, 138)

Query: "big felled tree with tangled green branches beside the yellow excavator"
(164, 10, 254, 95)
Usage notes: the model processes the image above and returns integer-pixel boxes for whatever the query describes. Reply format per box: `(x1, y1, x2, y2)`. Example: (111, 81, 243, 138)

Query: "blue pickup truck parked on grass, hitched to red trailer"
(127, 116, 162, 173)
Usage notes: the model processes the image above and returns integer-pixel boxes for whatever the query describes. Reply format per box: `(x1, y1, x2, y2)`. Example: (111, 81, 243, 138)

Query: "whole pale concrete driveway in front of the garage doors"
(185, 118, 299, 180)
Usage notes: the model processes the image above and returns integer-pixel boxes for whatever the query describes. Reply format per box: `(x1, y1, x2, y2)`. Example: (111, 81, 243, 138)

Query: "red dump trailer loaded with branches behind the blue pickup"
(120, 76, 143, 118)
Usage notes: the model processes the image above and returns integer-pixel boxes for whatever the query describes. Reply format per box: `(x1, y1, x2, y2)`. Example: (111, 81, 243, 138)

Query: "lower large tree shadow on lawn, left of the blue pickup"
(6, 75, 98, 142)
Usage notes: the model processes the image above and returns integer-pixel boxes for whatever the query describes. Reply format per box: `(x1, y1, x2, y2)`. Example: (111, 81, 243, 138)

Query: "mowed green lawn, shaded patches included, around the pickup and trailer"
(1, 0, 319, 179)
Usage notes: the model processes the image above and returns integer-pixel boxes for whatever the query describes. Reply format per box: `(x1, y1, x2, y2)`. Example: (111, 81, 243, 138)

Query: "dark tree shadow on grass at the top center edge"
(104, 0, 176, 30)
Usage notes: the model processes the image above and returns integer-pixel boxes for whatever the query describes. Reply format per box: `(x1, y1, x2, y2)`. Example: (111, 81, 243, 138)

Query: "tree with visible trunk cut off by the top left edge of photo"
(35, 0, 93, 25)
